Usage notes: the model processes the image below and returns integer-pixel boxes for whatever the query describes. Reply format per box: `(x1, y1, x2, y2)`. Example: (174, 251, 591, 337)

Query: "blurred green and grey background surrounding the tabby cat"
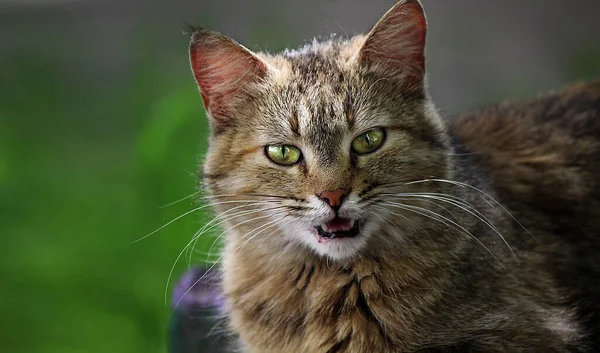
(0, 0, 600, 353)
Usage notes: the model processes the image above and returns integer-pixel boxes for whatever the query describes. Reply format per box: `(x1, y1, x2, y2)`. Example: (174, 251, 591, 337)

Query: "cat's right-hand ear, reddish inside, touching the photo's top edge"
(357, 0, 427, 88)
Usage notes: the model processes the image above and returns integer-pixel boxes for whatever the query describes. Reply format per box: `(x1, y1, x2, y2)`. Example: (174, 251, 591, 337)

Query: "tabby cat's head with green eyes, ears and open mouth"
(190, 0, 449, 259)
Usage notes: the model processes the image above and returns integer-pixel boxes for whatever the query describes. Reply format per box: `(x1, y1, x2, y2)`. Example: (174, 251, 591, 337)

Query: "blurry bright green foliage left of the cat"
(0, 40, 212, 353)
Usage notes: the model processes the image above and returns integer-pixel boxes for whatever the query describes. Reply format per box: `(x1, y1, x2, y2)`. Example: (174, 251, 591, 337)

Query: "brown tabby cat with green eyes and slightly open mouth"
(184, 0, 600, 353)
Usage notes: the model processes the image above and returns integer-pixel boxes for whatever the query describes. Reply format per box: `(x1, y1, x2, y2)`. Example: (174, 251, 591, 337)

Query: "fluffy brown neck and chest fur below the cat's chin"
(223, 221, 459, 353)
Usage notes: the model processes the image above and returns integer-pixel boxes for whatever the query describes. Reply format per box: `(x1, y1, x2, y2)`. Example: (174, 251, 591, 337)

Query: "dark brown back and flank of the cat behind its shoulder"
(449, 79, 600, 347)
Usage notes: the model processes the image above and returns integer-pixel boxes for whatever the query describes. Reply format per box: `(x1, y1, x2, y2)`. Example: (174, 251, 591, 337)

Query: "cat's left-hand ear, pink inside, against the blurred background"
(190, 29, 268, 125)
